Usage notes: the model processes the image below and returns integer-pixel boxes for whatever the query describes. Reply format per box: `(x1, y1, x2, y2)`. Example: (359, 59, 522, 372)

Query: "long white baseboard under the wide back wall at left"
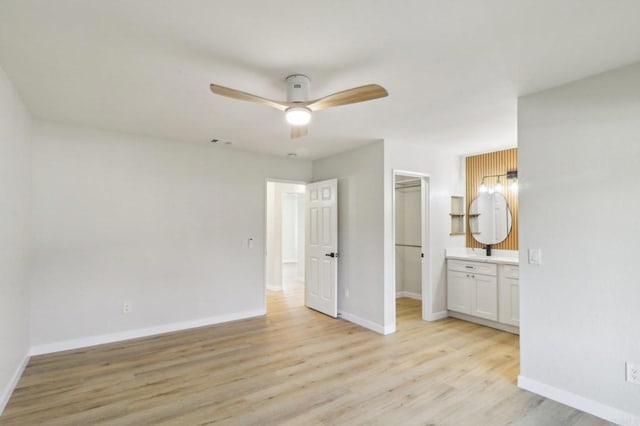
(29, 309, 266, 355)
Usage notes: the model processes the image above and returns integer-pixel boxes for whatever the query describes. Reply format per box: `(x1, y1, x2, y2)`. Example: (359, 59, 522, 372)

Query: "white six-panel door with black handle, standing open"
(305, 179, 338, 318)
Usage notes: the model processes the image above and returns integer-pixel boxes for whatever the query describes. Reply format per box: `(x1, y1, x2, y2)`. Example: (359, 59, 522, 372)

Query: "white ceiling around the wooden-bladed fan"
(0, 0, 640, 158)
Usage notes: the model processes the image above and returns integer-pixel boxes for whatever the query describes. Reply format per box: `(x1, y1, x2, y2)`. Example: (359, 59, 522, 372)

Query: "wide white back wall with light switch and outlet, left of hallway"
(31, 122, 311, 352)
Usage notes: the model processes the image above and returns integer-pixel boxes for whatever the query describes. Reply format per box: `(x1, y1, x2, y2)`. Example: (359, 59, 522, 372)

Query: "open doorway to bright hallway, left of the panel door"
(265, 181, 305, 304)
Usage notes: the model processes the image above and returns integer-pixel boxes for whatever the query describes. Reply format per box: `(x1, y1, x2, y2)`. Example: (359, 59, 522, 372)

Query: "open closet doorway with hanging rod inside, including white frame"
(393, 172, 429, 327)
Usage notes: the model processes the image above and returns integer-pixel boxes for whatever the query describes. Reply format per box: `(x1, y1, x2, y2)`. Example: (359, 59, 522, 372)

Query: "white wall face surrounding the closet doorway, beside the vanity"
(383, 140, 465, 330)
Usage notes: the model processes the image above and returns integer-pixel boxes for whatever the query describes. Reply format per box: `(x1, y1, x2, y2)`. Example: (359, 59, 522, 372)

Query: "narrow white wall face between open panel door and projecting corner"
(313, 142, 384, 332)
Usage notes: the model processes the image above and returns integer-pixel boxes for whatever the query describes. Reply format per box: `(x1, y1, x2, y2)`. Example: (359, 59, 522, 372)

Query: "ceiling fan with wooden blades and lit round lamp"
(210, 74, 389, 138)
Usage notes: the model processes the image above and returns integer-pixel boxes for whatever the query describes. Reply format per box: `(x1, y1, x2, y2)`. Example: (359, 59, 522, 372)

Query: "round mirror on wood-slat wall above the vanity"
(469, 192, 511, 244)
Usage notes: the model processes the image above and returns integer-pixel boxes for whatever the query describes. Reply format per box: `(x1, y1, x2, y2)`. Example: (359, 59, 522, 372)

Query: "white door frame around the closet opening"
(390, 169, 433, 322)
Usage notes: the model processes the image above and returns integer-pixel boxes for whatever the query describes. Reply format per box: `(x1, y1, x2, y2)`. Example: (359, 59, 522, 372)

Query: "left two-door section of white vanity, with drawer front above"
(447, 259, 498, 321)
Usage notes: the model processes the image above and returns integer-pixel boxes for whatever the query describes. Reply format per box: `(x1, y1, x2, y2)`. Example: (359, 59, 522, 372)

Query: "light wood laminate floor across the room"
(0, 288, 608, 426)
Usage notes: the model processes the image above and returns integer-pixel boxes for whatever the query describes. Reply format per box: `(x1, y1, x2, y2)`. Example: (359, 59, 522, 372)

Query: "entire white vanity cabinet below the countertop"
(447, 258, 520, 333)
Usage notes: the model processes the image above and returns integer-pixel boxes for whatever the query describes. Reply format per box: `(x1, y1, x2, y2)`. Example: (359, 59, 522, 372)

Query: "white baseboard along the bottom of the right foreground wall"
(518, 376, 640, 426)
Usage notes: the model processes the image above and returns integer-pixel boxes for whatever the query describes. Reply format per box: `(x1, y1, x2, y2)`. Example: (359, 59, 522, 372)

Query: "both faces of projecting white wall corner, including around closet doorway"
(313, 140, 465, 333)
